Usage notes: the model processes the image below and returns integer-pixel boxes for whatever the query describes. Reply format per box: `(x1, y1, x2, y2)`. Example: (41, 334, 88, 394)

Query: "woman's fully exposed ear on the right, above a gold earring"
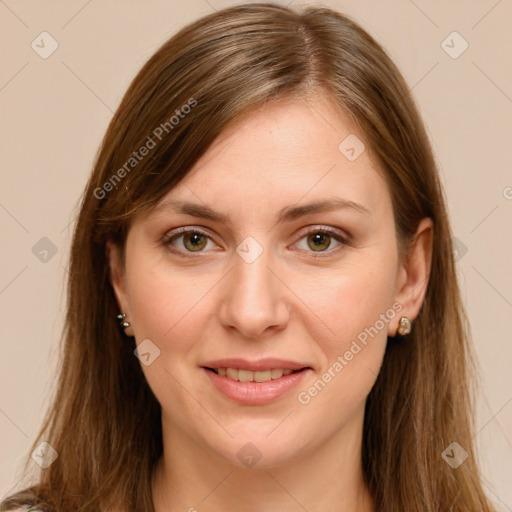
(390, 218, 434, 336)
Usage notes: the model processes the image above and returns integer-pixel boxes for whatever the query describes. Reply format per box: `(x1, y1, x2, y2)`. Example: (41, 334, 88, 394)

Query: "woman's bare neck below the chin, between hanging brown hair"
(153, 408, 374, 512)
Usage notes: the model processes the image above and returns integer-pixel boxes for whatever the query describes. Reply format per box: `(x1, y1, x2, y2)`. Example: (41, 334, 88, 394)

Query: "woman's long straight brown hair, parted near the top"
(2, 4, 494, 512)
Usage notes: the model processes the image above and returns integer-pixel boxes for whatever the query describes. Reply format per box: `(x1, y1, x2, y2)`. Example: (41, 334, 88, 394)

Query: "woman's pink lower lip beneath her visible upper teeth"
(203, 368, 310, 405)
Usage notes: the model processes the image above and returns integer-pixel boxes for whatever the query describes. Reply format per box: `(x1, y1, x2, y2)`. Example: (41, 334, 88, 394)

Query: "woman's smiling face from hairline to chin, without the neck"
(110, 94, 432, 467)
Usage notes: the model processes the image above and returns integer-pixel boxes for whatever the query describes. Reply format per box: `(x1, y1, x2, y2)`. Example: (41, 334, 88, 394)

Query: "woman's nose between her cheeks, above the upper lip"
(219, 244, 290, 338)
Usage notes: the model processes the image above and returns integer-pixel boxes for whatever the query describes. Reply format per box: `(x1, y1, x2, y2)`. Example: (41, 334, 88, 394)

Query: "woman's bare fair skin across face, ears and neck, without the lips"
(108, 95, 432, 512)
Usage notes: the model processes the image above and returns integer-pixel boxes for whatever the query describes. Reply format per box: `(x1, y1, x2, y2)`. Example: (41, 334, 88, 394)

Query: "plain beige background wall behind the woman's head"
(0, 0, 512, 510)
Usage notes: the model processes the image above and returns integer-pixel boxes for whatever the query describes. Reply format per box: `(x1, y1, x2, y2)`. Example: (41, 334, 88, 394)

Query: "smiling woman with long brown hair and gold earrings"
(2, 4, 494, 512)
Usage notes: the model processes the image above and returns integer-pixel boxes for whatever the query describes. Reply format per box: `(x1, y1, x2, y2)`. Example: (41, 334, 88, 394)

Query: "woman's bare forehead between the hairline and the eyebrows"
(154, 96, 390, 221)
